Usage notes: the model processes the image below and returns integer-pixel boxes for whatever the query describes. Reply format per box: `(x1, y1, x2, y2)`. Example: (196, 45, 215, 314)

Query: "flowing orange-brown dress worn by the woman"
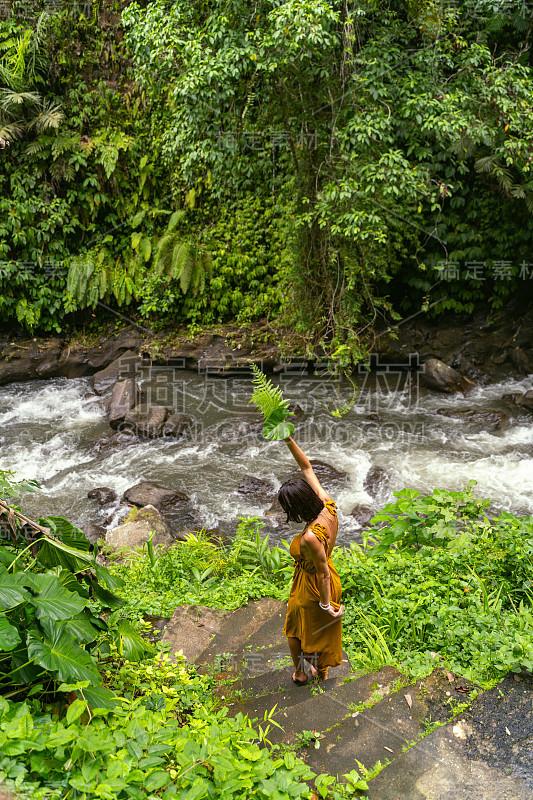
(283, 500, 342, 669)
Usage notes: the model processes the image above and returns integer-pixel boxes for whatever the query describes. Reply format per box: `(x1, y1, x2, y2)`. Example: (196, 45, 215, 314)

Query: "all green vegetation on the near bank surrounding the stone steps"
(0, 473, 533, 800)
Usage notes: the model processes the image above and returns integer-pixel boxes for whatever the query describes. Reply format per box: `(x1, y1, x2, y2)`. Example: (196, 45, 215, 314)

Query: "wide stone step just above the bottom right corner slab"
(305, 669, 474, 780)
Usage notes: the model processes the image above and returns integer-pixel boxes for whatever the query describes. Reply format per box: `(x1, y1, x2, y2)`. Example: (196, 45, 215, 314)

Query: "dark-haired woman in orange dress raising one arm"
(278, 436, 344, 686)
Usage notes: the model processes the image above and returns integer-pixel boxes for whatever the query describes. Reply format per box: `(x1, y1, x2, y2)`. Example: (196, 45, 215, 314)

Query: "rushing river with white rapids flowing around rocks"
(0, 370, 533, 543)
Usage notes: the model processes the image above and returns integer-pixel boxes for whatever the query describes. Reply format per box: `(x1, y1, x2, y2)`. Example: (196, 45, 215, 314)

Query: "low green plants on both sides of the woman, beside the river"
(112, 494, 533, 685)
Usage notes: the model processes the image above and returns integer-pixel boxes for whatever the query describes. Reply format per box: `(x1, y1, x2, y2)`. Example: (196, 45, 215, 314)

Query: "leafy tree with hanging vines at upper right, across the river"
(123, 0, 533, 363)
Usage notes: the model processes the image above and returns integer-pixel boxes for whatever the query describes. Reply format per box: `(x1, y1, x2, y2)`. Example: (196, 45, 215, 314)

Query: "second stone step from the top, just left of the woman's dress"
(191, 597, 285, 673)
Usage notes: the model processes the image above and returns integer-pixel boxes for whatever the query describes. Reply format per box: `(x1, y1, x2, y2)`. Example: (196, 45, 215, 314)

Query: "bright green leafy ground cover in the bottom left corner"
(0, 653, 313, 800)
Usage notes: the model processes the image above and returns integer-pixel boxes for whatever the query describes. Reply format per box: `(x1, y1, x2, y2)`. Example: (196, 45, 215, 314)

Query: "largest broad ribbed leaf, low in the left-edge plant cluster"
(27, 619, 102, 685)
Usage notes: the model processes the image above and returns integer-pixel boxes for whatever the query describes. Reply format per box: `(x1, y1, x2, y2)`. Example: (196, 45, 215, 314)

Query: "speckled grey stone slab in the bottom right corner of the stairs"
(366, 675, 533, 800)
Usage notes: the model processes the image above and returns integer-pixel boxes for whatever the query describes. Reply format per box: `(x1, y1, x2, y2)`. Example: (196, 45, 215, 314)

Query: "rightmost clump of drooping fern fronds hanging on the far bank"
(154, 210, 211, 295)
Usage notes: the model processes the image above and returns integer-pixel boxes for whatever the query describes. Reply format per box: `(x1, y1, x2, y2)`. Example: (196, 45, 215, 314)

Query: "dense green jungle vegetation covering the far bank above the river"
(0, 0, 533, 364)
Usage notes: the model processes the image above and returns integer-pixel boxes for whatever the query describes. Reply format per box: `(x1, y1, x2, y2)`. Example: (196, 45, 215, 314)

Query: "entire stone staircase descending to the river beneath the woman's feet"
(163, 598, 533, 800)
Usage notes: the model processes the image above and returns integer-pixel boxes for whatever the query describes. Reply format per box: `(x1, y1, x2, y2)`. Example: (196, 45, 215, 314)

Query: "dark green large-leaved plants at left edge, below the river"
(0, 472, 152, 706)
